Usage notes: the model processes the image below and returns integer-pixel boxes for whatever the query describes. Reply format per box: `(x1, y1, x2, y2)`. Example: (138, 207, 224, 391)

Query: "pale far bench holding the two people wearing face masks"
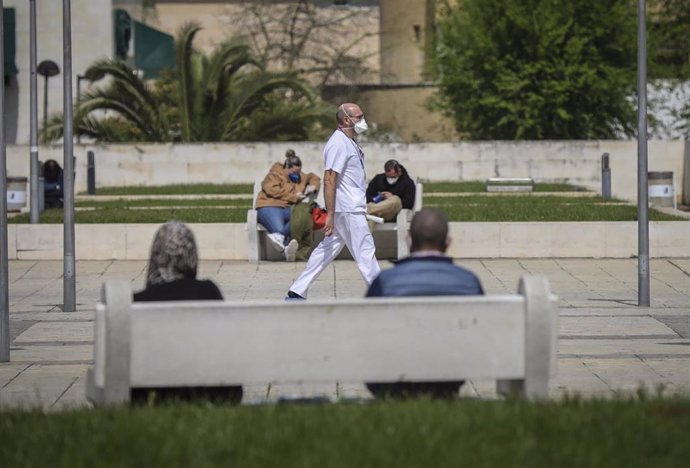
(247, 181, 424, 262)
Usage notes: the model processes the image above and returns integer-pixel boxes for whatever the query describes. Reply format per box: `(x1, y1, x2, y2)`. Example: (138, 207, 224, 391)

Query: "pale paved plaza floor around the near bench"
(0, 259, 690, 409)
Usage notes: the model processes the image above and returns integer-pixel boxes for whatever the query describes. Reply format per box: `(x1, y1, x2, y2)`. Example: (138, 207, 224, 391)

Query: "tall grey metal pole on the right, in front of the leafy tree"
(637, 0, 649, 307)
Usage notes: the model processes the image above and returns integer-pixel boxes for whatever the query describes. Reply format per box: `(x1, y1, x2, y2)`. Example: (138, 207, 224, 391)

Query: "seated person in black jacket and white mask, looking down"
(367, 159, 417, 228)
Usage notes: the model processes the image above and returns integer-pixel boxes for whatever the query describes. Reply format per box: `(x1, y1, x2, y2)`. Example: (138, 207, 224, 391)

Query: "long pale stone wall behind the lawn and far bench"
(7, 140, 685, 201)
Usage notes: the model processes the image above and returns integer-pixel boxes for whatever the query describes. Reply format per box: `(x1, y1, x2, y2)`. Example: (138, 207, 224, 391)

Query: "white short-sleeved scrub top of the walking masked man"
(323, 130, 367, 213)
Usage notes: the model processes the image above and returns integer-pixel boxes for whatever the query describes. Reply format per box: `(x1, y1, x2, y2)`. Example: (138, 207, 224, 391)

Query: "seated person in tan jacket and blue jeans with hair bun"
(256, 150, 321, 262)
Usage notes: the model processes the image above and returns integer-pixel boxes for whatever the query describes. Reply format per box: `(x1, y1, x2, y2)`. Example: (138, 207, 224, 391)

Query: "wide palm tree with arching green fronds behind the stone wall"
(43, 24, 330, 142)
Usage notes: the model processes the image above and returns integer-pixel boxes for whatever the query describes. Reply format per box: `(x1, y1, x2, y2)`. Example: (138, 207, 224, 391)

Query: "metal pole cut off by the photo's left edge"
(0, 0, 10, 362)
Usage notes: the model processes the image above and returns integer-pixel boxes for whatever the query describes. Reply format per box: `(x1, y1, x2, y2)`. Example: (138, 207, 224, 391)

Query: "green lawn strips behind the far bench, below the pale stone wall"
(8, 181, 683, 224)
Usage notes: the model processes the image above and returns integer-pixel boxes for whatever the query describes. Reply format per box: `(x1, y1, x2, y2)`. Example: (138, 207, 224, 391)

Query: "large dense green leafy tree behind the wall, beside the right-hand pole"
(436, 0, 636, 140)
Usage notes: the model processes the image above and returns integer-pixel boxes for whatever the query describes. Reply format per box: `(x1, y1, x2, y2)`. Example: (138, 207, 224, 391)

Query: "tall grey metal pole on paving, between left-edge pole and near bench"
(62, 0, 76, 312)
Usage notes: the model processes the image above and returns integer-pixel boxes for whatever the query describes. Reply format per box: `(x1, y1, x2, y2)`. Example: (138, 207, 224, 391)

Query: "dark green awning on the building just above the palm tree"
(113, 9, 175, 78)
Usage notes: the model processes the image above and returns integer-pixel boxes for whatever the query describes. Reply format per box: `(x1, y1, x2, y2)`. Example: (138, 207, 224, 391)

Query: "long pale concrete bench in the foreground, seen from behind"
(86, 276, 558, 405)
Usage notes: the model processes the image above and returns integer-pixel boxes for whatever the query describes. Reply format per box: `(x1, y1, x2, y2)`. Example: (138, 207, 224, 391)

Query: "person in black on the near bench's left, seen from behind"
(131, 221, 242, 403)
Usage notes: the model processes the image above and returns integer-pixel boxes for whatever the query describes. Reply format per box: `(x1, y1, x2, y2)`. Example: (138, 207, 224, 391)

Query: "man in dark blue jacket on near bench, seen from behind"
(366, 208, 484, 398)
